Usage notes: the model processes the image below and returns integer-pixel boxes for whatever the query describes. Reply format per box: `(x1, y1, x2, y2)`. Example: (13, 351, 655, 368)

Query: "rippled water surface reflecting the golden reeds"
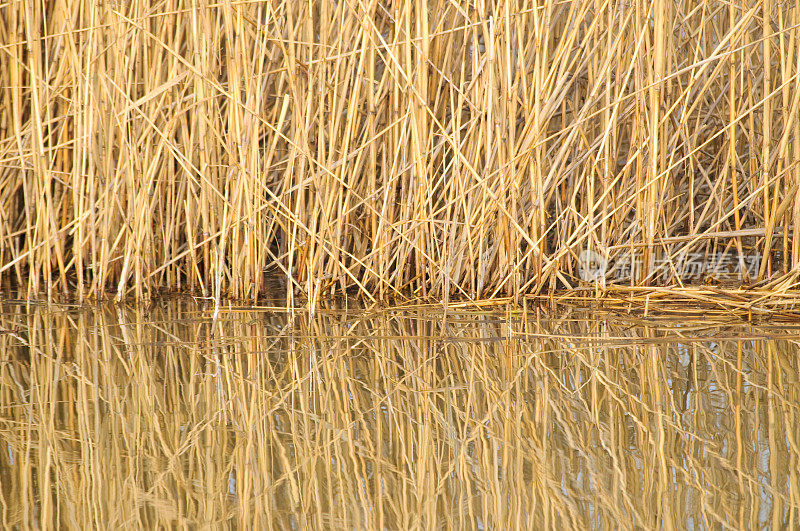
(0, 301, 800, 529)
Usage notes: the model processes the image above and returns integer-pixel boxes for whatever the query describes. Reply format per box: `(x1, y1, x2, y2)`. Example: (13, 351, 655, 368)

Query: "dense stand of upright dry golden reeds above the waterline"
(0, 0, 800, 298)
